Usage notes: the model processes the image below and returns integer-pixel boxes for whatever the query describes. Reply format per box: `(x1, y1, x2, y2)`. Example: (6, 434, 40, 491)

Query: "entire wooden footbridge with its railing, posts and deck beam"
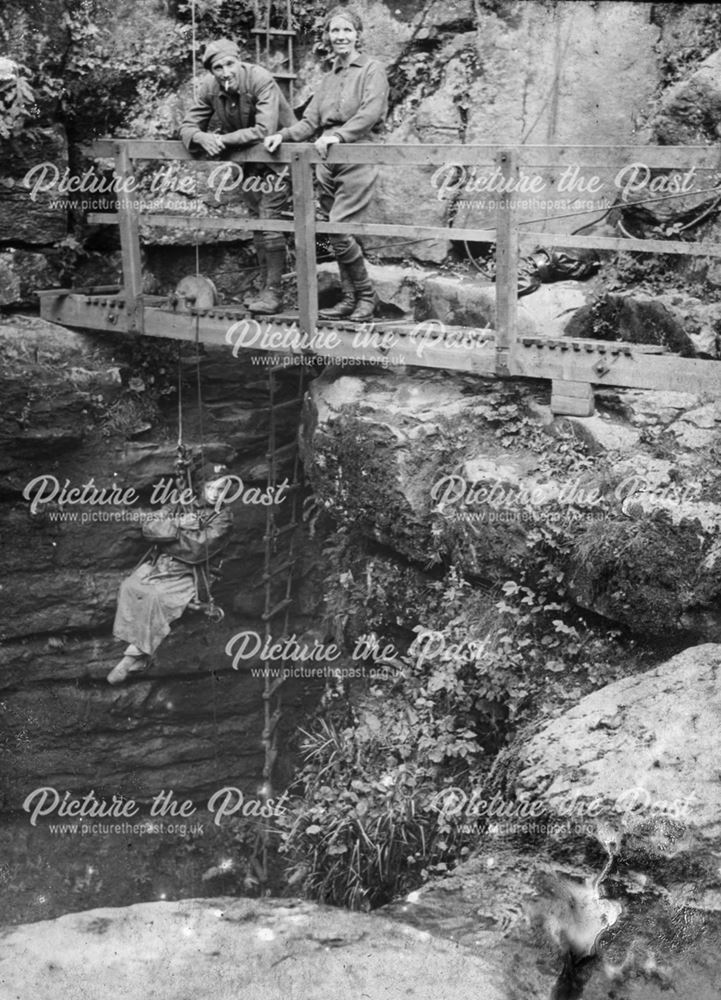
(39, 139, 721, 415)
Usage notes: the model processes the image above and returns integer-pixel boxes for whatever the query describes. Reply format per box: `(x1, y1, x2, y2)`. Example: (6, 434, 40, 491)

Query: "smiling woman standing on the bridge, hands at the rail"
(264, 7, 388, 321)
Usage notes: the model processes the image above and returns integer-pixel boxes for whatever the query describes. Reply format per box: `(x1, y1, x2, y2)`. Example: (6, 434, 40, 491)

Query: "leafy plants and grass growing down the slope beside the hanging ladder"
(278, 402, 641, 908)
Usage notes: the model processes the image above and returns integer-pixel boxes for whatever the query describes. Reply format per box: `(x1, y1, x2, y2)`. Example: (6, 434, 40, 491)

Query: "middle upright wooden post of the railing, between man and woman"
(291, 150, 318, 337)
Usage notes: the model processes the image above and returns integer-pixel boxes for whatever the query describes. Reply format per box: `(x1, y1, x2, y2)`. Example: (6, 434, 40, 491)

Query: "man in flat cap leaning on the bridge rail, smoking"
(180, 38, 296, 313)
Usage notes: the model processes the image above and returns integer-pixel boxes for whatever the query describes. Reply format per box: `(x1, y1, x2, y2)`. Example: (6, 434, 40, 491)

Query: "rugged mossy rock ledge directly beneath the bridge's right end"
(303, 362, 721, 639)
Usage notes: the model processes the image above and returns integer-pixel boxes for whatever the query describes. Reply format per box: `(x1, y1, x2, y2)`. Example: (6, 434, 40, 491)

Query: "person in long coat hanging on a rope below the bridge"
(107, 461, 233, 684)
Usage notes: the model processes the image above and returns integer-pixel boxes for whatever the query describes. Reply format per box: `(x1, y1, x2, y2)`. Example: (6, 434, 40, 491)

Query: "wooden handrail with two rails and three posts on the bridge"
(84, 139, 721, 360)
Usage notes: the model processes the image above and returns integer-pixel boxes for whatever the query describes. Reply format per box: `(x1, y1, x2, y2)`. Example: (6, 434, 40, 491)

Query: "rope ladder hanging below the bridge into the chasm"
(254, 365, 304, 891)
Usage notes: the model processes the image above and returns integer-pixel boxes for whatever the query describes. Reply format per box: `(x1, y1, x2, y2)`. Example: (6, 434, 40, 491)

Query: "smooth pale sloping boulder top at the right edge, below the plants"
(516, 643, 721, 858)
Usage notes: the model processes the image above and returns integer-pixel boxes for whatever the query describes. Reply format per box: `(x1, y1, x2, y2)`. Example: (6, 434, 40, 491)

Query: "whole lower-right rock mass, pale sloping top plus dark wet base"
(382, 644, 721, 1000)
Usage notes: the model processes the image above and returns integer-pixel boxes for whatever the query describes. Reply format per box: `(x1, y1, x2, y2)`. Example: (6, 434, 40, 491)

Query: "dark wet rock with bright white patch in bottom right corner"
(381, 844, 721, 1000)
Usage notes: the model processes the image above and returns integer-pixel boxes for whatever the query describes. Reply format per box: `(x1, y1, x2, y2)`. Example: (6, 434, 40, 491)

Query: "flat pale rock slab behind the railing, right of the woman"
(452, 3, 659, 233)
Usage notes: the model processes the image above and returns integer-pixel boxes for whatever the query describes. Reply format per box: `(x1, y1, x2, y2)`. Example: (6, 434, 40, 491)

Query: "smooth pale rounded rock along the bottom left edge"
(0, 899, 512, 1000)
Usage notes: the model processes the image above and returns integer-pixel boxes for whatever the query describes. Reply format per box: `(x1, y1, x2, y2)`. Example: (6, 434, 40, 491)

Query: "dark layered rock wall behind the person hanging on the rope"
(0, 318, 314, 808)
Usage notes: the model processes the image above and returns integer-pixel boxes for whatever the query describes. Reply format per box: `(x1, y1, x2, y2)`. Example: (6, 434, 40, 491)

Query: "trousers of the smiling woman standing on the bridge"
(316, 163, 378, 264)
